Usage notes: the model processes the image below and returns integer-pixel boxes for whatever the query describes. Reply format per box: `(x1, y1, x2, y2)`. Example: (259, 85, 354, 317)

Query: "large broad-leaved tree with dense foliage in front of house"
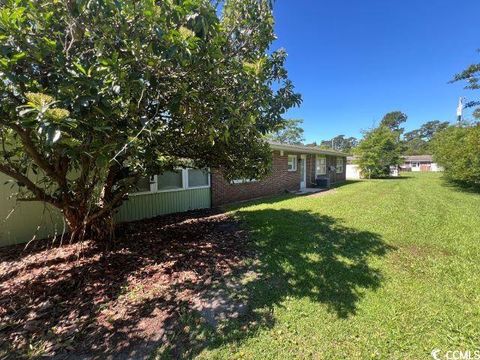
(0, 0, 301, 239)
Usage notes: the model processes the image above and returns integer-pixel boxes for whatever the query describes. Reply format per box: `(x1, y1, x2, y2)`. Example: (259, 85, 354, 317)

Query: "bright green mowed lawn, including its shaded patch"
(191, 174, 480, 359)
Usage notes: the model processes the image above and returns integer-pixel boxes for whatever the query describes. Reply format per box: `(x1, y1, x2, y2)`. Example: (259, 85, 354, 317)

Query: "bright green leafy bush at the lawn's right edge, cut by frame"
(433, 124, 480, 186)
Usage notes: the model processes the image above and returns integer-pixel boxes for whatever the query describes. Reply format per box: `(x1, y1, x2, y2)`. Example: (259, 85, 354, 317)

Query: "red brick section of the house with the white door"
(211, 142, 346, 206)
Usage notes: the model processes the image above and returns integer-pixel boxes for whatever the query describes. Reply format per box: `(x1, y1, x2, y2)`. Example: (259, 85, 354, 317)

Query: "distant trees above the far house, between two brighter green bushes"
(403, 120, 449, 155)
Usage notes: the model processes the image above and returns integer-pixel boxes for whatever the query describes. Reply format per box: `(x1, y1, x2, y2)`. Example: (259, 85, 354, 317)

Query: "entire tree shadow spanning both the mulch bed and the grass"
(0, 207, 393, 359)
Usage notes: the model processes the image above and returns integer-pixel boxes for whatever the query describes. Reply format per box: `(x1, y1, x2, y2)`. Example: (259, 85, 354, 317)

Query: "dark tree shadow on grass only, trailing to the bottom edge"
(158, 209, 394, 355)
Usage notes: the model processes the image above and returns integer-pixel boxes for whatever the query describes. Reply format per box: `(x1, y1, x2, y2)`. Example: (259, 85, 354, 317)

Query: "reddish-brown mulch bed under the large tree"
(0, 210, 246, 359)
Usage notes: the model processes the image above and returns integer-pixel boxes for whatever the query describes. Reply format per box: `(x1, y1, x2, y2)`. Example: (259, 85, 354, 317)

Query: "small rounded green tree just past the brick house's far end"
(355, 125, 402, 178)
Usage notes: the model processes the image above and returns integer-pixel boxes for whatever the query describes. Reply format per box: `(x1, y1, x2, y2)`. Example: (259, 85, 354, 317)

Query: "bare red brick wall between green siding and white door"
(212, 151, 300, 206)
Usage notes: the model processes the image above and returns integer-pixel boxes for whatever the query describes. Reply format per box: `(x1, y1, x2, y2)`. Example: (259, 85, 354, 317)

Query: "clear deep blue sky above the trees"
(274, 0, 480, 141)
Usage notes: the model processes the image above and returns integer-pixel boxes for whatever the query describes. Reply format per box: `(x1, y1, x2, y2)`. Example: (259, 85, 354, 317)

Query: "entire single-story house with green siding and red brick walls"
(0, 142, 346, 246)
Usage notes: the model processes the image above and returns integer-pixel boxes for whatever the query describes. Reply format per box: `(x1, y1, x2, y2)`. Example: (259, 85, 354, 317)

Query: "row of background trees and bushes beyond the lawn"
(270, 48, 480, 188)
